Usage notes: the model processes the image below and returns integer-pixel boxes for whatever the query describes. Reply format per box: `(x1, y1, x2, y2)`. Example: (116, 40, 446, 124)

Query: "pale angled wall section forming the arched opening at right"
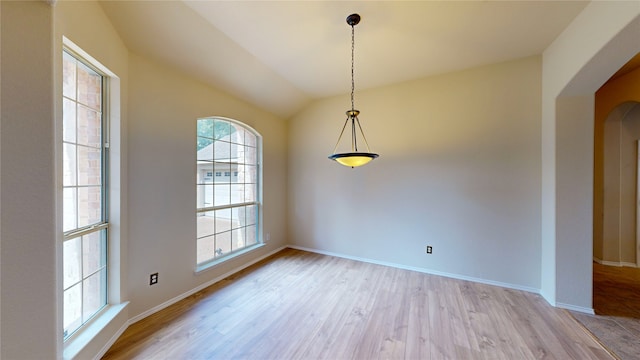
(541, 2, 640, 313)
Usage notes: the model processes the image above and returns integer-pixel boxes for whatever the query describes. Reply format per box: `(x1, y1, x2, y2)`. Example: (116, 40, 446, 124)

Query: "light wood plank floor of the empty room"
(103, 249, 612, 360)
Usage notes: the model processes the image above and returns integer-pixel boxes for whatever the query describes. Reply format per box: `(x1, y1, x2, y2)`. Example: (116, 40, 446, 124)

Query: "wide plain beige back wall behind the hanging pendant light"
(289, 57, 541, 291)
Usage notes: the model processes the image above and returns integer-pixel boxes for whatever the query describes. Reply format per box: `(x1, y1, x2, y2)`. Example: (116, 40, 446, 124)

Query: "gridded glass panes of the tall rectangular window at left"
(62, 51, 108, 339)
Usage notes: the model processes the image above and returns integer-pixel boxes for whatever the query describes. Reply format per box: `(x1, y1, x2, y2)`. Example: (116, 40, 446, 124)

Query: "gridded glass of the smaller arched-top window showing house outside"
(196, 118, 261, 267)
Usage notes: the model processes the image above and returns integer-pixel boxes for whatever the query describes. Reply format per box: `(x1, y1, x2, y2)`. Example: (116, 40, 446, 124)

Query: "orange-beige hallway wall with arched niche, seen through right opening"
(593, 69, 640, 265)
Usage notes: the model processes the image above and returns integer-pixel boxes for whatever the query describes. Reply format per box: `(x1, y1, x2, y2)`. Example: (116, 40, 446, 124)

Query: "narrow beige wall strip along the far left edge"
(0, 1, 57, 359)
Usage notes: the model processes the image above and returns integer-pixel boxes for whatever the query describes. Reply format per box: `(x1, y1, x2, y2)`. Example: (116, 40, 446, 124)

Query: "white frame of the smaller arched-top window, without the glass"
(195, 116, 265, 272)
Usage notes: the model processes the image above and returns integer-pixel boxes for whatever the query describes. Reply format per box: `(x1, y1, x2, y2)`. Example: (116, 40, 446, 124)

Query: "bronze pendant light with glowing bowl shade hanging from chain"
(329, 14, 379, 168)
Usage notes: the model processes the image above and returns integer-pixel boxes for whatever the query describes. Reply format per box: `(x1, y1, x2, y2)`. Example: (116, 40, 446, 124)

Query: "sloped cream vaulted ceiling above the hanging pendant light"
(101, 0, 588, 118)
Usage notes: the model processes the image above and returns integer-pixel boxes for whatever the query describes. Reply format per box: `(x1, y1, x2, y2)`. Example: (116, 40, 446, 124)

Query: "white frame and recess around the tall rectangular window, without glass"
(61, 36, 129, 359)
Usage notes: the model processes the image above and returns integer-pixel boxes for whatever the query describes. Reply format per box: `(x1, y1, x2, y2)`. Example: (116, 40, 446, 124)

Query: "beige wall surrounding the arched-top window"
(128, 54, 287, 317)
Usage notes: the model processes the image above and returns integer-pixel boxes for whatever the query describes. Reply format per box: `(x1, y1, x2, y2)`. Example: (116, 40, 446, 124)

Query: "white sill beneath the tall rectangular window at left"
(63, 302, 129, 359)
